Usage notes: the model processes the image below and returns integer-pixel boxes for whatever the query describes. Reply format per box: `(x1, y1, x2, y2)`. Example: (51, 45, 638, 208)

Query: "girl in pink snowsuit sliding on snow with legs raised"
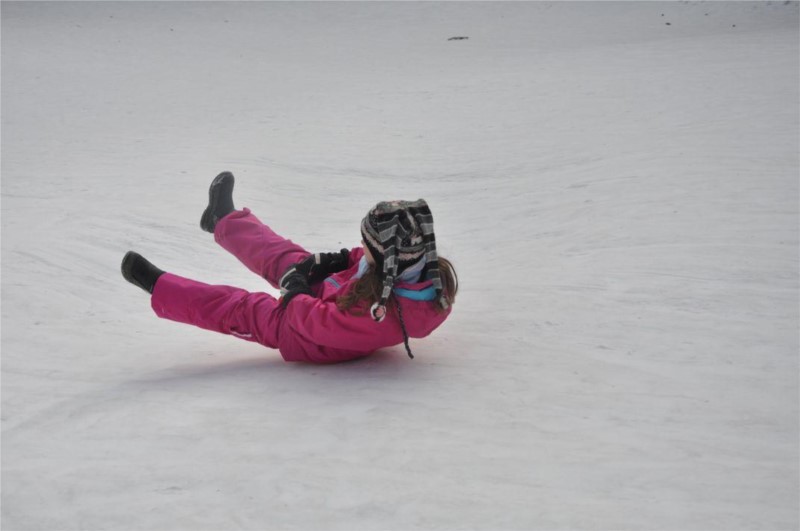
(122, 172, 458, 363)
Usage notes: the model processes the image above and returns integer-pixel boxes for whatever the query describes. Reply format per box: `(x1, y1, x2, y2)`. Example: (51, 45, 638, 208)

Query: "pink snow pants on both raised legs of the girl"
(150, 208, 309, 356)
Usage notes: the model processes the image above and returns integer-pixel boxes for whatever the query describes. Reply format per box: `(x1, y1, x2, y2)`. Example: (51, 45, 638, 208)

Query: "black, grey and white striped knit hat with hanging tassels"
(361, 199, 448, 321)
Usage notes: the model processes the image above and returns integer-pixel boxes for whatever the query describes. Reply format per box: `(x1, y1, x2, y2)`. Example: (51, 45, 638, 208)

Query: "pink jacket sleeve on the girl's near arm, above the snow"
(285, 294, 403, 352)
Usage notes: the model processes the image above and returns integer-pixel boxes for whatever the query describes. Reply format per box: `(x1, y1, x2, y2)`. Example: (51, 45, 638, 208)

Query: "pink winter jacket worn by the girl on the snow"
(278, 247, 452, 363)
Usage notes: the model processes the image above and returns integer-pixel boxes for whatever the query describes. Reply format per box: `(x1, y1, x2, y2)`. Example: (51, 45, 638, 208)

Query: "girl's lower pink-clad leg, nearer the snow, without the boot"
(150, 273, 283, 348)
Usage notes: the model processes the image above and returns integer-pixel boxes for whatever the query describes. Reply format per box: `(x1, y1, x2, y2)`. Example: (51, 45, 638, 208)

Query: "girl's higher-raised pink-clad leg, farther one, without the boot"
(214, 208, 310, 288)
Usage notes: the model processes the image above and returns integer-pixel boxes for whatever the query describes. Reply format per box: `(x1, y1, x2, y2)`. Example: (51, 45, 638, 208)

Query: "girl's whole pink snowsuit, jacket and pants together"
(151, 208, 451, 363)
